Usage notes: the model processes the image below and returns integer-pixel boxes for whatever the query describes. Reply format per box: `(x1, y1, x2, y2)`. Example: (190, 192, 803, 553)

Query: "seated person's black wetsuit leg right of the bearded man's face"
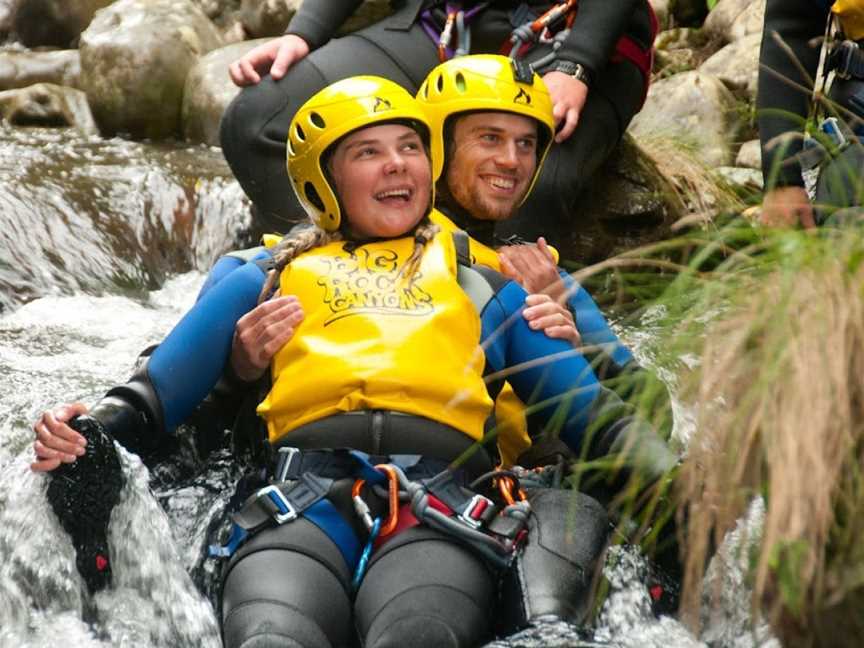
(495, 62, 643, 246)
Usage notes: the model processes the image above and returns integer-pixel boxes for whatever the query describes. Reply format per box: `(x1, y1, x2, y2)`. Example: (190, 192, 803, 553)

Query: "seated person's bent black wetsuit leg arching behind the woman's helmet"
(221, 19, 438, 231)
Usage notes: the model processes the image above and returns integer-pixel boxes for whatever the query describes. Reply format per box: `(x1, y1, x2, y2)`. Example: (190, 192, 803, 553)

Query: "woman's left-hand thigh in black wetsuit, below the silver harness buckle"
(222, 518, 354, 648)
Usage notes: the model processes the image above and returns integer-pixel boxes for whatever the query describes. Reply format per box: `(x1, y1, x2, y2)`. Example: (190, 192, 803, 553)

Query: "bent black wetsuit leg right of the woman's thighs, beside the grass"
(501, 489, 609, 632)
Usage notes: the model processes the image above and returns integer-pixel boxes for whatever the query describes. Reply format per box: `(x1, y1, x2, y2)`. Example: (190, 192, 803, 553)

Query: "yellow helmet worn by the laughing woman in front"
(286, 76, 430, 232)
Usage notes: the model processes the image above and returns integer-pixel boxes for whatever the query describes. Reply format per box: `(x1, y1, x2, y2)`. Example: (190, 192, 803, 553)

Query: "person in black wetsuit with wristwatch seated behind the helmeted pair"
(221, 0, 656, 245)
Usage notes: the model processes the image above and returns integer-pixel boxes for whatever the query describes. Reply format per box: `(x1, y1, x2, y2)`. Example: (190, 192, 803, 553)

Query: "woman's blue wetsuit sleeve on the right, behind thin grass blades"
(481, 281, 614, 452)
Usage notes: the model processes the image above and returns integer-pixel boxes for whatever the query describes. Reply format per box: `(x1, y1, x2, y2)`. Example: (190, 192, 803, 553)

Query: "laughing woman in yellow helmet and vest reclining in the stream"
(33, 77, 674, 648)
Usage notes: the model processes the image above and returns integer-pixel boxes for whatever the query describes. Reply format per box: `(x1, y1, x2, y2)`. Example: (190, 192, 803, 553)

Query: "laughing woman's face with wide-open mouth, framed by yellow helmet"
(329, 124, 432, 238)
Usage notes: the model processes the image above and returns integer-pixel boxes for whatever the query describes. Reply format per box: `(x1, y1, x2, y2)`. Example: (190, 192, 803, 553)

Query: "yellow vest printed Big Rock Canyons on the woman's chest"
(258, 231, 492, 444)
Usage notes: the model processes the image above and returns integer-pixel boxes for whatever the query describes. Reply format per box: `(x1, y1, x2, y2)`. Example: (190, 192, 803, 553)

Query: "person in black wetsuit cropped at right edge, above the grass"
(757, 0, 864, 227)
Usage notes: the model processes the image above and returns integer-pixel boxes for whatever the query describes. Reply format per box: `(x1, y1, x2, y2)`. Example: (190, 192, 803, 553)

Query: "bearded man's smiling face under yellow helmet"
(446, 112, 537, 220)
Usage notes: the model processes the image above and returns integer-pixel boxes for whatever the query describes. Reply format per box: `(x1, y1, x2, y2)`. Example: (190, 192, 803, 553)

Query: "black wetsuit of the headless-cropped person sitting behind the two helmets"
(221, 0, 651, 244)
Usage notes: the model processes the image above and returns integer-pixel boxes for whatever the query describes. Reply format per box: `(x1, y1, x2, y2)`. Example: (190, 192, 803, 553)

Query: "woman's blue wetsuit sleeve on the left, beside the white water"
(147, 262, 266, 430)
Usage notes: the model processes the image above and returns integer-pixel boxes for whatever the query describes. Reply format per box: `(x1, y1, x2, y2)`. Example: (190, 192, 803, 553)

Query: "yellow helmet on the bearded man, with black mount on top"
(417, 54, 555, 201)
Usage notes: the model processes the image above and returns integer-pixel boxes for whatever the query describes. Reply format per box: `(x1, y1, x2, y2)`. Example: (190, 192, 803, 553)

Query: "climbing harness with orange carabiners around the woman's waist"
(210, 448, 531, 568)
